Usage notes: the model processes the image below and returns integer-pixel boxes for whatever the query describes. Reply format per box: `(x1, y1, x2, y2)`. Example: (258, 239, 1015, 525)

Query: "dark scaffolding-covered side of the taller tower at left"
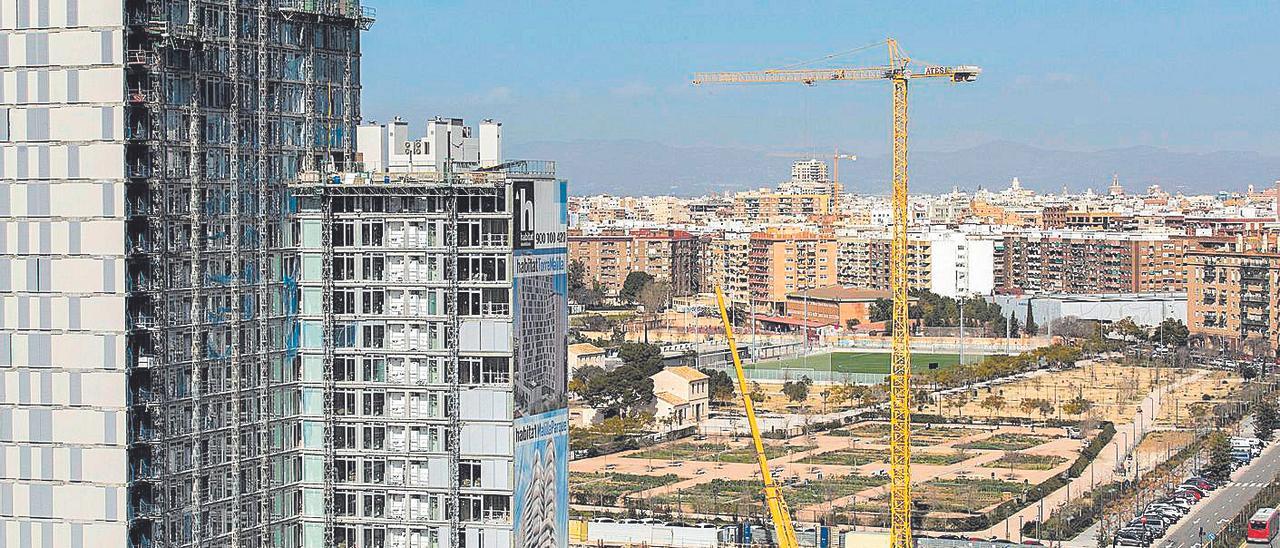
(124, 0, 374, 548)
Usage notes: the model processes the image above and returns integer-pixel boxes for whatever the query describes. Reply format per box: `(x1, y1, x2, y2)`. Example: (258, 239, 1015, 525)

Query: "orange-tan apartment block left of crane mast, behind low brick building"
(748, 229, 837, 315)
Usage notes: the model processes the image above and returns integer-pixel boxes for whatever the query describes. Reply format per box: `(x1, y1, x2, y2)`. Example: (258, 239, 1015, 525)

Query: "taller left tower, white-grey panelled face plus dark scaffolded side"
(0, 0, 371, 547)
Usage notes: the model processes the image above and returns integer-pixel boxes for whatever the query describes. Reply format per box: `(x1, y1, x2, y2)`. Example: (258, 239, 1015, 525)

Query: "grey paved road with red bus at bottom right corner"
(1155, 428, 1280, 548)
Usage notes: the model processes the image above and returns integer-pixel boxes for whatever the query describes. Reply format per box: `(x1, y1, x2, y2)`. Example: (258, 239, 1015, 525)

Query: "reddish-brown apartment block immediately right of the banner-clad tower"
(568, 229, 704, 296)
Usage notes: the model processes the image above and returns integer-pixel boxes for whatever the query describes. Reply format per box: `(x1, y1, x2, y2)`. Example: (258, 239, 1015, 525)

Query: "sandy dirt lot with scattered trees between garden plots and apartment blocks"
(942, 364, 1185, 423)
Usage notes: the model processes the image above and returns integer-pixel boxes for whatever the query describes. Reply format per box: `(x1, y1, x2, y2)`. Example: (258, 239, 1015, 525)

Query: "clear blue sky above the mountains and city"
(362, 0, 1280, 155)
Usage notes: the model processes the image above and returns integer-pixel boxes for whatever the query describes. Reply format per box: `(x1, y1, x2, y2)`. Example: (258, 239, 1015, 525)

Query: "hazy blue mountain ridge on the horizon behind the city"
(506, 140, 1280, 196)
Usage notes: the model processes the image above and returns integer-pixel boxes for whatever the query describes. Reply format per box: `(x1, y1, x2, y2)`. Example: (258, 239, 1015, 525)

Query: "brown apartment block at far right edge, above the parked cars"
(1187, 233, 1280, 352)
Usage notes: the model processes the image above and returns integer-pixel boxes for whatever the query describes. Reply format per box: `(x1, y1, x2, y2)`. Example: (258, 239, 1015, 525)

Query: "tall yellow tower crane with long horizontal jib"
(694, 38, 982, 548)
